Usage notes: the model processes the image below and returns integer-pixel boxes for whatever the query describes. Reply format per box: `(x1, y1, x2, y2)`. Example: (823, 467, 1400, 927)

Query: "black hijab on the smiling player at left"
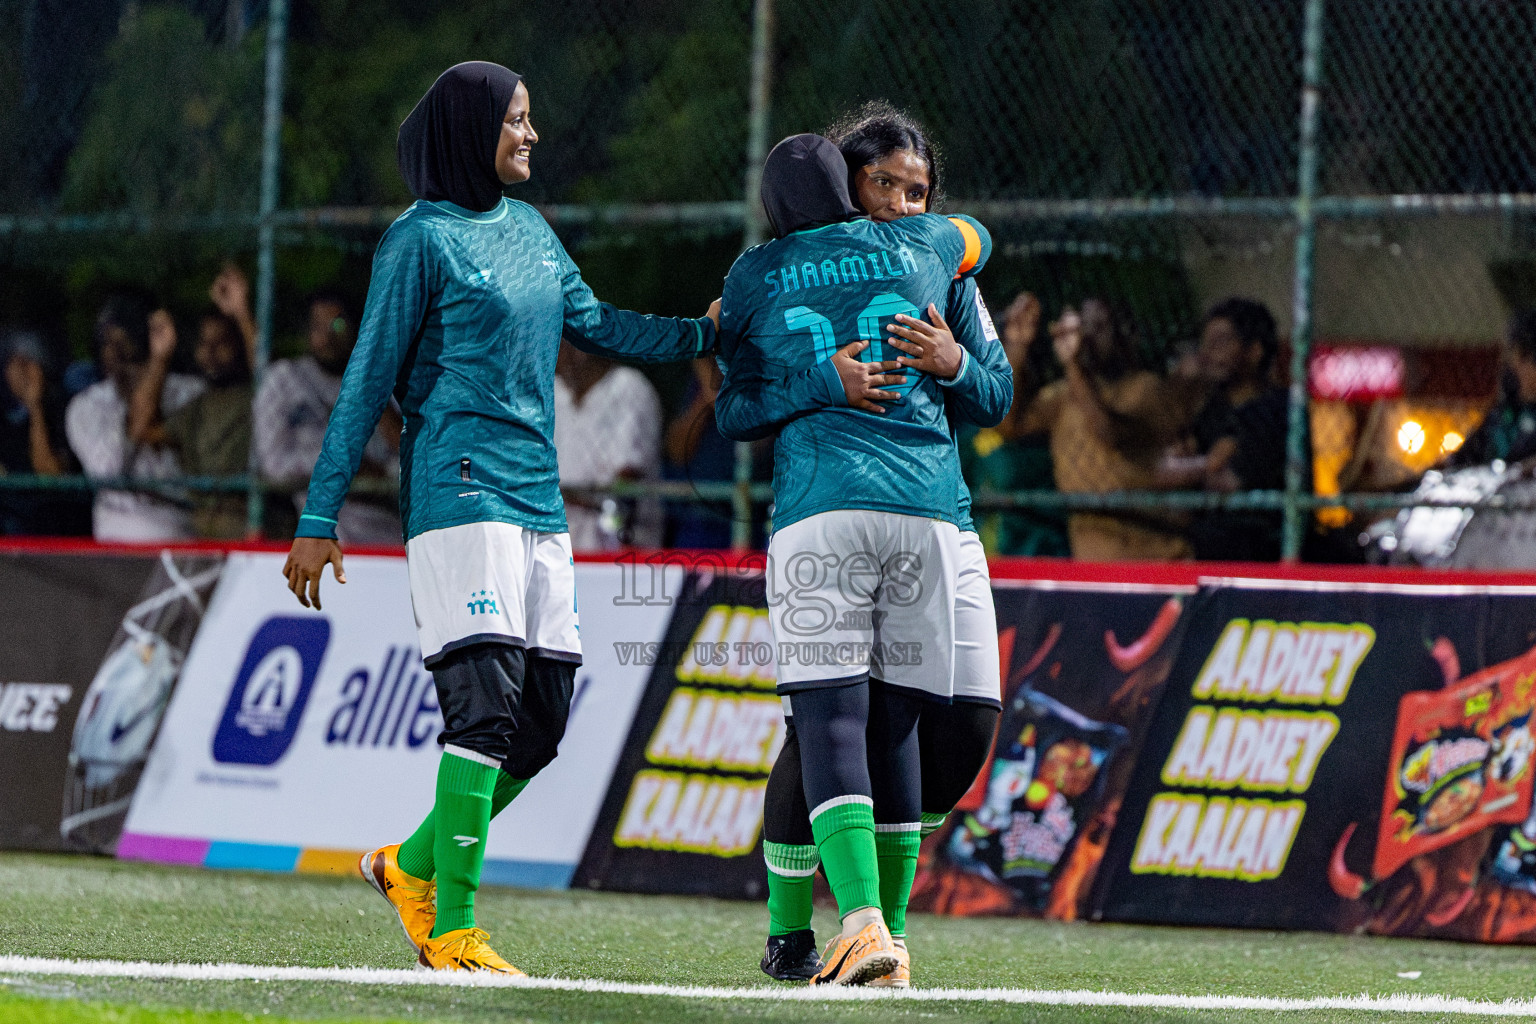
(395, 60, 522, 213)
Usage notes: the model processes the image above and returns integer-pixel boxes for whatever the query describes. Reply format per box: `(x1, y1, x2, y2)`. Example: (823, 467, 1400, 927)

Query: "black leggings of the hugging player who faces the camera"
(763, 699, 1001, 846)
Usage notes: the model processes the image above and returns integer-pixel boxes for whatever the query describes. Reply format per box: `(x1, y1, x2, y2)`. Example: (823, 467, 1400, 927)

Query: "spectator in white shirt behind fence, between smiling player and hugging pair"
(554, 342, 662, 551)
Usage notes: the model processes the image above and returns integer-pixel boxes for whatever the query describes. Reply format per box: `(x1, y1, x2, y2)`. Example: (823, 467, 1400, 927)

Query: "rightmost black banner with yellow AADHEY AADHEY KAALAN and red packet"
(1103, 580, 1536, 941)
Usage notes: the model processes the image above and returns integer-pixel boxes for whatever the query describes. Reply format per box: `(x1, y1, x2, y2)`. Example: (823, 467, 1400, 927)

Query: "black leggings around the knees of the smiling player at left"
(432, 643, 576, 778)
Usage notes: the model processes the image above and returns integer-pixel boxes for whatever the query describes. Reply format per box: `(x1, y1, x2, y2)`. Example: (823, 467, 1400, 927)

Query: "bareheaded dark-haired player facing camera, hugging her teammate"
(746, 103, 1014, 986)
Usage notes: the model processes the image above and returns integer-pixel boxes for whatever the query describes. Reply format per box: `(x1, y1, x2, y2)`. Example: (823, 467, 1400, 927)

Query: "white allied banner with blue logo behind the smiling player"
(118, 553, 667, 887)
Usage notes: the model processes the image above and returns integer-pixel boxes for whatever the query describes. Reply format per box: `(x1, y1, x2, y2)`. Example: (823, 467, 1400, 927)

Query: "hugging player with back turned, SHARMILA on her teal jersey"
(716, 135, 991, 984)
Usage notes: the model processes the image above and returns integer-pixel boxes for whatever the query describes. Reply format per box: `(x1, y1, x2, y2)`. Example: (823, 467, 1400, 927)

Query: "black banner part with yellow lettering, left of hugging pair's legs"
(574, 570, 785, 898)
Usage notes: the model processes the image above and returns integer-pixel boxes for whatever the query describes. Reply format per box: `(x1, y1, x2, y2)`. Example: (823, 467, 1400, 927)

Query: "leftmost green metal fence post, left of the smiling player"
(246, 0, 287, 536)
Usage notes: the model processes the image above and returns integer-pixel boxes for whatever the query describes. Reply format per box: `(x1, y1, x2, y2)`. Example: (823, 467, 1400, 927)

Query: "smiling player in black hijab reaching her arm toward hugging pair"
(284, 61, 714, 973)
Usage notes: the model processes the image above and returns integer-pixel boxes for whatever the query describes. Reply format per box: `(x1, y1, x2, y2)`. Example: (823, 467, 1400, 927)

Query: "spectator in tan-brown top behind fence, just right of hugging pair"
(998, 291, 1193, 562)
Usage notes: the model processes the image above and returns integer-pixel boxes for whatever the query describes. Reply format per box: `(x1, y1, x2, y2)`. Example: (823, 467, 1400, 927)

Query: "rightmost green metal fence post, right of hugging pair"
(1281, 0, 1324, 562)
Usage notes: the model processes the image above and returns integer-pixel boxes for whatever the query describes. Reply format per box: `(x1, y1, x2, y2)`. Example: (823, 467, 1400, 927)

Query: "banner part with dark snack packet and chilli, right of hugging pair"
(912, 582, 1193, 920)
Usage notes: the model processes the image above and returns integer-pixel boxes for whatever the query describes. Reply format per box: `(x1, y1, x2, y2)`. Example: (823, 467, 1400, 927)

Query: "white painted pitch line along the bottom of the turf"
(0, 956, 1536, 1016)
